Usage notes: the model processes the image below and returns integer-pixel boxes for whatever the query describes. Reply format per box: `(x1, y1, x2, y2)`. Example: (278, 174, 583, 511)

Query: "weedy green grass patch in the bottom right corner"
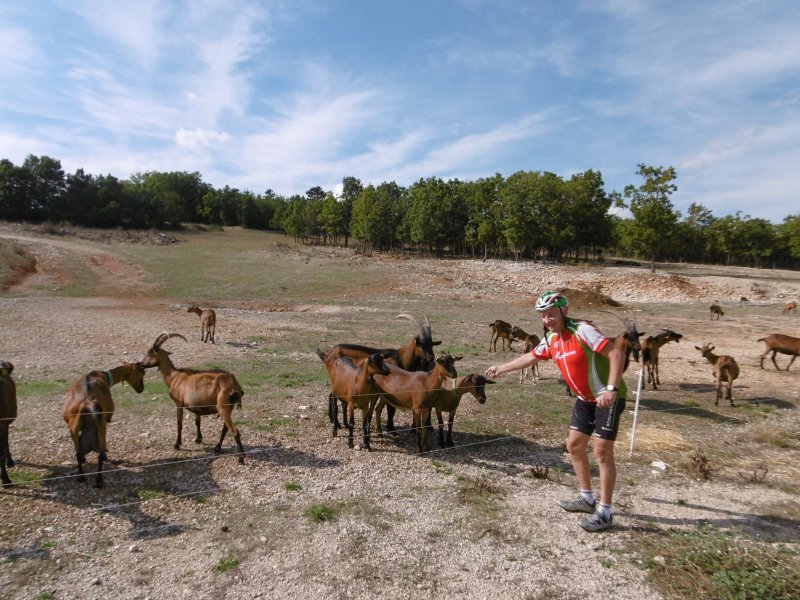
(641, 526, 800, 600)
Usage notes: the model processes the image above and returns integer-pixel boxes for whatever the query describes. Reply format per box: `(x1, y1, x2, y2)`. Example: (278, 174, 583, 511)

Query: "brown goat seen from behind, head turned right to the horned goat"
(62, 363, 144, 488)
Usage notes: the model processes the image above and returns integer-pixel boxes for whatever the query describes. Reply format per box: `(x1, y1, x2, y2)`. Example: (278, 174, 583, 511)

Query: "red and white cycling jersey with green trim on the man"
(531, 319, 628, 402)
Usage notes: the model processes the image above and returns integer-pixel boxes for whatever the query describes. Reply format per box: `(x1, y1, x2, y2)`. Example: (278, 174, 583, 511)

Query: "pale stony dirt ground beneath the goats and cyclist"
(0, 226, 800, 599)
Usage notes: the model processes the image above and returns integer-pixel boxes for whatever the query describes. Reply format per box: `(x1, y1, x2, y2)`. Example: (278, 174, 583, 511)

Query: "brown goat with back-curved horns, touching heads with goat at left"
(139, 332, 244, 465)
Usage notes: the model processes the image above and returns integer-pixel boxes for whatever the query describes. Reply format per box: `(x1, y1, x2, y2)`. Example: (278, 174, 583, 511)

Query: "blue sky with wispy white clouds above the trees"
(0, 0, 800, 223)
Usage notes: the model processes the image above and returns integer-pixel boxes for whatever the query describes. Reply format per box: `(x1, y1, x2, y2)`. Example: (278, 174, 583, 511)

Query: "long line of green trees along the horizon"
(0, 155, 800, 268)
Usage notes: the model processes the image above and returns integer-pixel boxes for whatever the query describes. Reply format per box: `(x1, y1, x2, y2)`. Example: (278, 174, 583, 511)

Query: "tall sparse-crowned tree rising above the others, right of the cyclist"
(625, 164, 680, 273)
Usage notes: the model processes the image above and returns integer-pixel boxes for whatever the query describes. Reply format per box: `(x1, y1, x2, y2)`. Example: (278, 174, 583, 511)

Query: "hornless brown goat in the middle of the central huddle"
(374, 354, 462, 454)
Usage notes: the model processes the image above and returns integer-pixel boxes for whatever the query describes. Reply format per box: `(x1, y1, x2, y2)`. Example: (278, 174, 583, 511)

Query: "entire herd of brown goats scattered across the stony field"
(0, 298, 800, 487)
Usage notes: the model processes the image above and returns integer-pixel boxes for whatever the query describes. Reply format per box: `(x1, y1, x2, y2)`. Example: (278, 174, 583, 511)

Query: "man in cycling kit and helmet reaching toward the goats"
(486, 292, 627, 532)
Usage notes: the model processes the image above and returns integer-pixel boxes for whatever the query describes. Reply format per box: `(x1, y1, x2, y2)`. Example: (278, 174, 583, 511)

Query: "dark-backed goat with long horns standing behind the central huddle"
(328, 313, 442, 436)
